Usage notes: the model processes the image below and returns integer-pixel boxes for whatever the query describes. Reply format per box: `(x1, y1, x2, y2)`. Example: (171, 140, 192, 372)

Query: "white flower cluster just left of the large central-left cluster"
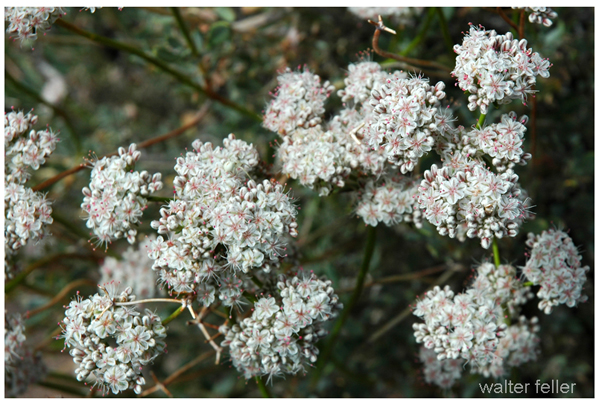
(81, 143, 162, 247)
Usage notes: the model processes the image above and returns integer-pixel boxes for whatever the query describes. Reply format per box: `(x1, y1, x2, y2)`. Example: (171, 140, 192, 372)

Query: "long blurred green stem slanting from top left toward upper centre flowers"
(54, 18, 262, 122)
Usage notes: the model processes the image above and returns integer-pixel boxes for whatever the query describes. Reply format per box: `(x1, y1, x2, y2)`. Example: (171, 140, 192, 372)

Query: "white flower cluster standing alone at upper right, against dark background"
(452, 26, 551, 114)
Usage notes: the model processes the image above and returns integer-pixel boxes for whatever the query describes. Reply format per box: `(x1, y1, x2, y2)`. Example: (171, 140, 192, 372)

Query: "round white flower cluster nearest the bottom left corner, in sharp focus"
(62, 282, 166, 394)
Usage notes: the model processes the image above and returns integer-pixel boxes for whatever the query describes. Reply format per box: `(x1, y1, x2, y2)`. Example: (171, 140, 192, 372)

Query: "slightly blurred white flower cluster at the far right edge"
(522, 229, 589, 314)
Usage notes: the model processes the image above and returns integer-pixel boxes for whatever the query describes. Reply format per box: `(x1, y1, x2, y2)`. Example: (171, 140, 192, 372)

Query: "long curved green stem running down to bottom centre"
(311, 226, 376, 388)
